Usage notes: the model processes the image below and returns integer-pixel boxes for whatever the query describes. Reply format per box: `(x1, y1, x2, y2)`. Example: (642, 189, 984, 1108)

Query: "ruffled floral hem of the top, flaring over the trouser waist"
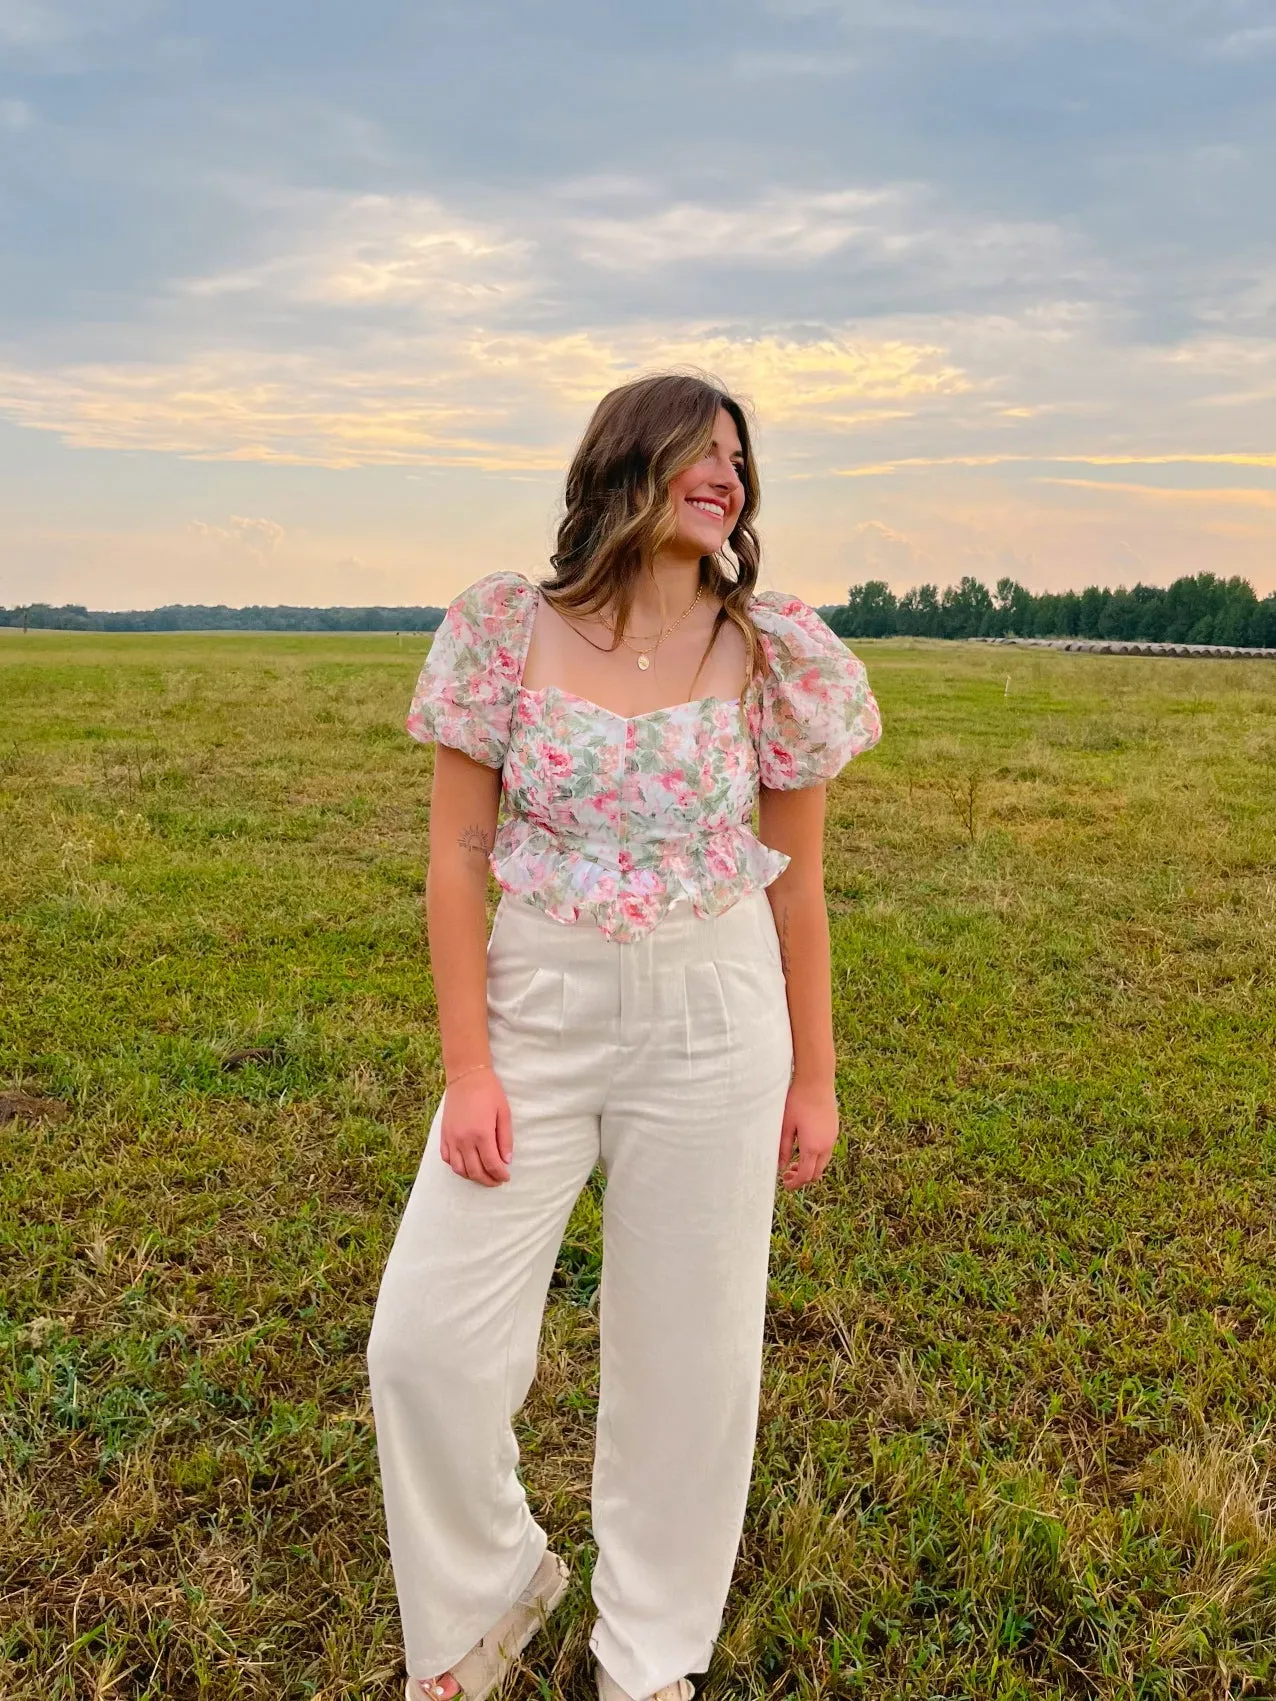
(488, 822, 789, 944)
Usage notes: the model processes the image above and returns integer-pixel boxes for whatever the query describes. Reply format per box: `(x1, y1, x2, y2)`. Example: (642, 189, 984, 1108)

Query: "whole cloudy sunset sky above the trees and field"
(0, 0, 1276, 609)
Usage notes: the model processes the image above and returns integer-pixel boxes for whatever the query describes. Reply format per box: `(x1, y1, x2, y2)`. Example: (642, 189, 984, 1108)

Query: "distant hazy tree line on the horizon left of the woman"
(0, 602, 446, 633)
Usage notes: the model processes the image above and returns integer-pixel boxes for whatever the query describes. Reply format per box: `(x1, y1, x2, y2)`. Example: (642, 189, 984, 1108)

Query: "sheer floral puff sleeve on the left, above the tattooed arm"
(405, 573, 536, 767)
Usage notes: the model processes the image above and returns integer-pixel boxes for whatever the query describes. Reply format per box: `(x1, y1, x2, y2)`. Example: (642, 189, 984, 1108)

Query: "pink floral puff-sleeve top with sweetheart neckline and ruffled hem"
(407, 573, 881, 944)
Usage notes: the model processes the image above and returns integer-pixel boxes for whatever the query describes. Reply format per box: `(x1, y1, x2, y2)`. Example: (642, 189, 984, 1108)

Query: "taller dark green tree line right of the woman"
(820, 573, 1276, 648)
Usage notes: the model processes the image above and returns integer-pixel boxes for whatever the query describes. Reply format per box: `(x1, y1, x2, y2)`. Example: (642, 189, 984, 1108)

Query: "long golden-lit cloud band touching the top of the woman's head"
(0, 327, 968, 471)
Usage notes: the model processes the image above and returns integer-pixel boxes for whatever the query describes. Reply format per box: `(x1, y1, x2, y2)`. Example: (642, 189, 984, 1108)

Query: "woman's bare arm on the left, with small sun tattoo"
(425, 743, 514, 1187)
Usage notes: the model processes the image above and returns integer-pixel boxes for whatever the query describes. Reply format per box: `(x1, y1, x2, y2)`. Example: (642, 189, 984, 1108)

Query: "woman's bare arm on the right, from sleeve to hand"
(759, 786, 837, 1191)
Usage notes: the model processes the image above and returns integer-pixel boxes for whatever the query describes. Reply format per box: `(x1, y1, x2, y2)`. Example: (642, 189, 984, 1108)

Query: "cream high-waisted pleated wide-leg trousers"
(367, 891, 793, 1696)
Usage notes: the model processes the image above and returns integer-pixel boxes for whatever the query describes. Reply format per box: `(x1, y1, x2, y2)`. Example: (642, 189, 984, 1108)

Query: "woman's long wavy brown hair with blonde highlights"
(541, 373, 766, 684)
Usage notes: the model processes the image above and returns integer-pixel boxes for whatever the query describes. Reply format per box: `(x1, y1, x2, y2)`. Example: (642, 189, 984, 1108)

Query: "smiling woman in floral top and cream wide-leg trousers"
(369, 376, 881, 1701)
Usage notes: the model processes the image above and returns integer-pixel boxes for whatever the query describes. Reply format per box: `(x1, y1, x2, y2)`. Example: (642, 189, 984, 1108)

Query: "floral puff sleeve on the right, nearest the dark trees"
(750, 590, 881, 791)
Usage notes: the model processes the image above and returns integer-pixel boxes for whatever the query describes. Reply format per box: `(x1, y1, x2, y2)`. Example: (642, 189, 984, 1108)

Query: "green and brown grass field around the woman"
(0, 633, 1276, 1701)
